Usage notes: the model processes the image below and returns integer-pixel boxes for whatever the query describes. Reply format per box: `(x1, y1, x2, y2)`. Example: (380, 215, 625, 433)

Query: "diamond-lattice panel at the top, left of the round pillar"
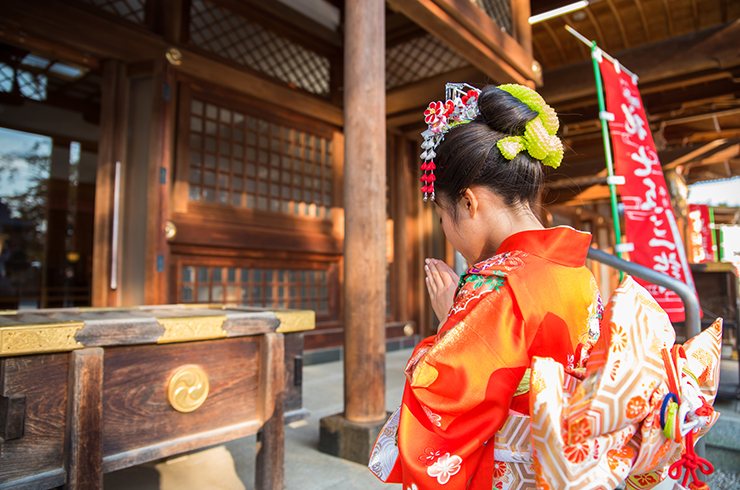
(190, 0, 329, 95)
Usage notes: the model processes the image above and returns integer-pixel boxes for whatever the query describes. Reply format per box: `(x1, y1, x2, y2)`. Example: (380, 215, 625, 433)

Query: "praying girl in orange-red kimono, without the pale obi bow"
(371, 86, 602, 490)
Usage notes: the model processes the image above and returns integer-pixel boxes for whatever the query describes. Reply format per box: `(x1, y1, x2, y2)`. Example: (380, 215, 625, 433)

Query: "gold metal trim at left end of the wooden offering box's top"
(0, 322, 85, 357)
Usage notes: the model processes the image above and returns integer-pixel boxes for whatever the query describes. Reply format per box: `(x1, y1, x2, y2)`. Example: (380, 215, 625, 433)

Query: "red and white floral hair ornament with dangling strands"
(420, 83, 480, 201)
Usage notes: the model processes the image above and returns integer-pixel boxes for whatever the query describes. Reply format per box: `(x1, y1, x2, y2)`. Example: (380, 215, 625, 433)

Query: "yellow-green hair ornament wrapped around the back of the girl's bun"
(496, 84, 563, 168)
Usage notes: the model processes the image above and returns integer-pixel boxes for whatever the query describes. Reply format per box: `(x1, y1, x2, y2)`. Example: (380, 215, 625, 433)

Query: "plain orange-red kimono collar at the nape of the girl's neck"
(496, 226, 591, 267)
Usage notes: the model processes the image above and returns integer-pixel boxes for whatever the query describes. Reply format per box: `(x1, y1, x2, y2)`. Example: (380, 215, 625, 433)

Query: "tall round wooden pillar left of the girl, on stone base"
(344, 0, 386, 422)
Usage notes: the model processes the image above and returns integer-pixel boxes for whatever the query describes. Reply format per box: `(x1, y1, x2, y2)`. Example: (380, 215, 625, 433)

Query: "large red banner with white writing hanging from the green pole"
(600, 60, 695, 322)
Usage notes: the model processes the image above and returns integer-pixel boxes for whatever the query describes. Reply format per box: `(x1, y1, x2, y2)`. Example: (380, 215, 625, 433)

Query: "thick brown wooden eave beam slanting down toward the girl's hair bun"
(387, 0, 541, 84)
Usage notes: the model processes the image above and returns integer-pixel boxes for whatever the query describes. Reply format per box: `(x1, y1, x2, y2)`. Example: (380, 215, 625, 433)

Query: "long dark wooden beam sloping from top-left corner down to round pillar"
(3, 0, 343, 126)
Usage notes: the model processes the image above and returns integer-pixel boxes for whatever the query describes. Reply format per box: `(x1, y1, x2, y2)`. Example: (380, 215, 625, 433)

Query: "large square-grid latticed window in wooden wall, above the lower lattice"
(188, 98, 332, 219)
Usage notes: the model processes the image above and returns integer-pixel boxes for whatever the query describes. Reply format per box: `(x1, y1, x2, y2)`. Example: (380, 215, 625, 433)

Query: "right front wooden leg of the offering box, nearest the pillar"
(255, 333, 285, 490)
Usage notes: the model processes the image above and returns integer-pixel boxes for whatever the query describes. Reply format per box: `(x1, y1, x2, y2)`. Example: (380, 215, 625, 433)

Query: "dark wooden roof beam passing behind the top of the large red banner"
(540, 21, 740, 105)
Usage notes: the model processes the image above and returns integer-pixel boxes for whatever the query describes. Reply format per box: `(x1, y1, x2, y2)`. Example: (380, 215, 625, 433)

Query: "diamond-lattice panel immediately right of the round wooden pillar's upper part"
(385, 34, 469, 89)
